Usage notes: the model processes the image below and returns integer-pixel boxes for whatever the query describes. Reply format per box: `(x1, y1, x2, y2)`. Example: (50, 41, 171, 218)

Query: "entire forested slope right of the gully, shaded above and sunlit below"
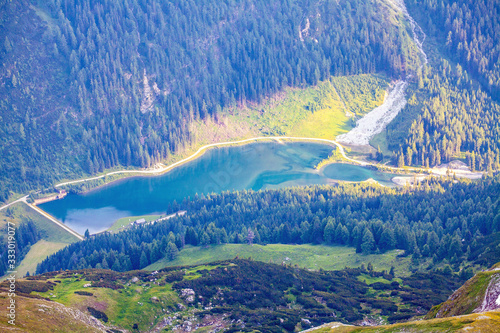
(387, 0, 500, 171)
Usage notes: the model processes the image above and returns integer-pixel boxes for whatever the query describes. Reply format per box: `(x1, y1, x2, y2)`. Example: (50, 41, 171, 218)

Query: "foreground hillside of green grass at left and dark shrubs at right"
(0, 259, 461, 332)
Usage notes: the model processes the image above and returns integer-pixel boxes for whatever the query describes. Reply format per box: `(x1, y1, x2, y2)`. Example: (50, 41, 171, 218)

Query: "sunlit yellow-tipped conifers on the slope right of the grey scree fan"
(387, 60, 500, 171)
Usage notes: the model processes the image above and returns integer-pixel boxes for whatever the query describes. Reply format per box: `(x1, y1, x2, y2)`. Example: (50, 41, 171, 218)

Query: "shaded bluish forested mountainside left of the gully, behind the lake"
(0, 0, 418, 199)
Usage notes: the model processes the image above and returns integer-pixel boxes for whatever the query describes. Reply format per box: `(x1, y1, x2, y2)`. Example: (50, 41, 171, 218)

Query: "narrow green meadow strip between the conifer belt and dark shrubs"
(145, 244, 422, 276)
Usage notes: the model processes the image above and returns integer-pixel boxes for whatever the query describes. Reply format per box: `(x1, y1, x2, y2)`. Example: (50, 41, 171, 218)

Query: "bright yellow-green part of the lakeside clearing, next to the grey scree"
(241, 75, 388, 139)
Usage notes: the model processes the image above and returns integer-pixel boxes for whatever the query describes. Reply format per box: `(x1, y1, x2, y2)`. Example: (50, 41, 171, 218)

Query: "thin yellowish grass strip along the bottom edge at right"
(310, 311, 500, 333)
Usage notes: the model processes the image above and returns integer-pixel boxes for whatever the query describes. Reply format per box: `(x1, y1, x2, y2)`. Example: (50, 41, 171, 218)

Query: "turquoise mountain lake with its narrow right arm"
(40, 142, 394, 234)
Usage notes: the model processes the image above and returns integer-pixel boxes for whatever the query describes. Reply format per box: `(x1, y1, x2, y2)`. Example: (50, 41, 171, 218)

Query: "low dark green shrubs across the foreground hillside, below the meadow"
(7, 259, 463, 326)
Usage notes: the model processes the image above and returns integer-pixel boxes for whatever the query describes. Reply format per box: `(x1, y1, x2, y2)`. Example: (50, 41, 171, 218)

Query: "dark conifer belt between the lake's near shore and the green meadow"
(37, 178, 500, 273)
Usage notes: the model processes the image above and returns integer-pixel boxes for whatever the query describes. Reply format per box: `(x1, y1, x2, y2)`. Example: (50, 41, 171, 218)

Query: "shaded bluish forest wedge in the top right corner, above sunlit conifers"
(407, 0, 500, 99)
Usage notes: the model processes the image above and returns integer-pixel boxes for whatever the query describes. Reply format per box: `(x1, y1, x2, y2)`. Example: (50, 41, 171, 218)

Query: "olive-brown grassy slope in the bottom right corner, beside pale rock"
(426, 264, 500, 319)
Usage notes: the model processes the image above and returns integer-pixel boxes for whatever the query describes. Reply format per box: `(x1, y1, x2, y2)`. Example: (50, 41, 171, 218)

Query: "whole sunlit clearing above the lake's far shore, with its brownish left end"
(191, 74, 388, 145)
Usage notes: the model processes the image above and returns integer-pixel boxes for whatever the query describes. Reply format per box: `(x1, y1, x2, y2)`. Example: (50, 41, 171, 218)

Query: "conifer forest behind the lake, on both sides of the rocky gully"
(0, 0, 500, 200)
